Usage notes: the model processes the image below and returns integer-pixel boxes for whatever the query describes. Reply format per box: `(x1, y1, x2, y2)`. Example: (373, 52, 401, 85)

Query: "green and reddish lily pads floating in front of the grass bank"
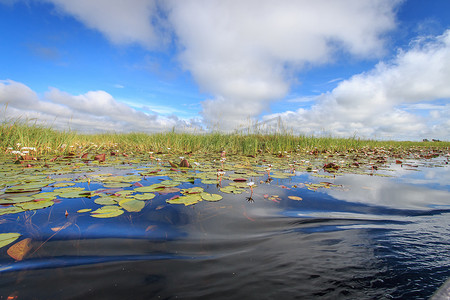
(0, 149, 446, 218)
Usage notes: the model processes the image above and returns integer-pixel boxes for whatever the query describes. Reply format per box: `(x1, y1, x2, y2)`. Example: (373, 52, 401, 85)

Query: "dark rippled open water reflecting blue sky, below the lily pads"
(0, 161, 450, 299)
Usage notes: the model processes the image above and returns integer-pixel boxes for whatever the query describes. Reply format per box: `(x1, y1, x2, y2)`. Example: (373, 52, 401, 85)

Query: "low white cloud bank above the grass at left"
(0, 80, 202, 132)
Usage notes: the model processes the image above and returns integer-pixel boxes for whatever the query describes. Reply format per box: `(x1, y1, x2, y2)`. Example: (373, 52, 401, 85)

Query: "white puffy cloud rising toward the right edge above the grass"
(265, 30, 450, 139)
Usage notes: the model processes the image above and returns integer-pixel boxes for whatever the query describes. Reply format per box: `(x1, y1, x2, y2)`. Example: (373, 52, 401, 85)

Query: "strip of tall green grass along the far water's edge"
(0, 121, 450, 155)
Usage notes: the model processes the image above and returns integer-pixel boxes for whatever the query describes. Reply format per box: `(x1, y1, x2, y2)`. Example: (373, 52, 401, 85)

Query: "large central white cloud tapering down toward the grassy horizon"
(169, 0, 399, 129)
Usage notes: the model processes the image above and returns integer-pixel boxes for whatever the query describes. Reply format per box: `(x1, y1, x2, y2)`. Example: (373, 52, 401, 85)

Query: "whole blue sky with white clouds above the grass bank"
(0, 0, 450, 141)
